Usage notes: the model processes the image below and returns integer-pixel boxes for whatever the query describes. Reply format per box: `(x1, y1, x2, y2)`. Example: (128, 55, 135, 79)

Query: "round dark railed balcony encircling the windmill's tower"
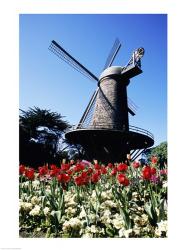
(65, 123, 154, 151)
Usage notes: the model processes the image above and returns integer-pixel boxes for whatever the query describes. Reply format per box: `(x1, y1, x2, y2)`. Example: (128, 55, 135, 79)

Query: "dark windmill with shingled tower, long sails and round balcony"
(49, 39, 154, 162)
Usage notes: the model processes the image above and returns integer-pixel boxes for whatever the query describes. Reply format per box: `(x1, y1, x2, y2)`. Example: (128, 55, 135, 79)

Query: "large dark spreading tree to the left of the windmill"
(19, 107, 70, 167)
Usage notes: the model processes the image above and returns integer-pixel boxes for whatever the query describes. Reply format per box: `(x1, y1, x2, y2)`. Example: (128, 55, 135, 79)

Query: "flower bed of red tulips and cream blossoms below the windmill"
(19, 158, 167, 238)
